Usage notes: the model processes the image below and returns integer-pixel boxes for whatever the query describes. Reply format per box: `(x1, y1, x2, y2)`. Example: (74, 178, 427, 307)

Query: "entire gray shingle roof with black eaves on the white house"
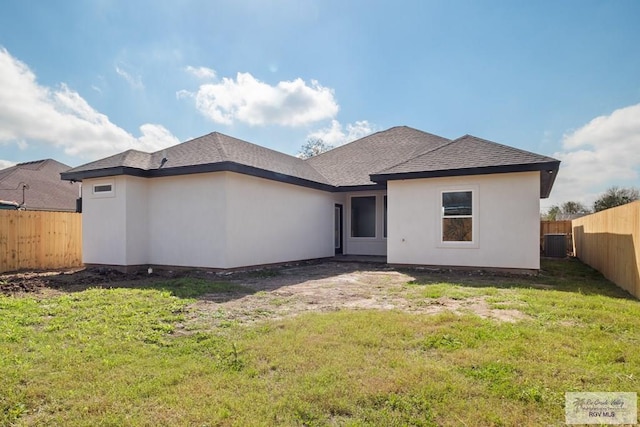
(62, 126, 560, 197)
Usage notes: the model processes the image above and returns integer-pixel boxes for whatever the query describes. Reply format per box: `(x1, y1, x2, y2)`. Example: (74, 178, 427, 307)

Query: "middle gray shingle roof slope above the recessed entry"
(307, 126, 450, 187)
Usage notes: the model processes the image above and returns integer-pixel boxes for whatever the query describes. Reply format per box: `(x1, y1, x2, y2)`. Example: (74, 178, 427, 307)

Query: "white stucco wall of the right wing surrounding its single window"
(387, 172, 540, 269)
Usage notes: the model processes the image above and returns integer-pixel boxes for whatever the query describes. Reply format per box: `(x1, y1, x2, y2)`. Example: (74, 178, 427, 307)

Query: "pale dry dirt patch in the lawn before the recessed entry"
(183, 262, 527, 329)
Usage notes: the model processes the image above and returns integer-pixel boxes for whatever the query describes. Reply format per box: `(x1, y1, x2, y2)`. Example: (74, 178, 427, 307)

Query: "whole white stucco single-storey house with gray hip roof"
(62, 126, 560, 270)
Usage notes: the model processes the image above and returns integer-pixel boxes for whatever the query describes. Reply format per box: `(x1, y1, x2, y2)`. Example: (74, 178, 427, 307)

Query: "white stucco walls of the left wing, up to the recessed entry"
(83, 172, 344, 268)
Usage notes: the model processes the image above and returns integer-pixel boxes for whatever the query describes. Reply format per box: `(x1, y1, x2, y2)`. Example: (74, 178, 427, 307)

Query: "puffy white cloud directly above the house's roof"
(181, 73, 339, 126)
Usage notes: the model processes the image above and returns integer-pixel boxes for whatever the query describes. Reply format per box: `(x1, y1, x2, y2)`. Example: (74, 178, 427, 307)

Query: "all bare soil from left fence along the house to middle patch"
(0, 262, 526, 333)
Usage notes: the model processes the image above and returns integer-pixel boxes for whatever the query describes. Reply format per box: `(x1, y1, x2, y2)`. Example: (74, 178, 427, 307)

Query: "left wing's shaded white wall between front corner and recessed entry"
(226, 173, 336, 268)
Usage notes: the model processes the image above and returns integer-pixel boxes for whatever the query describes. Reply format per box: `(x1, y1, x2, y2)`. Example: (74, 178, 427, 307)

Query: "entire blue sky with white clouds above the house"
(0, 0, 640, 208)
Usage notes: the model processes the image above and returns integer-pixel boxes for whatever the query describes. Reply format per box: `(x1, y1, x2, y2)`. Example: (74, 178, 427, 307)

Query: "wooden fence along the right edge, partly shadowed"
(573, 201, 640, 298)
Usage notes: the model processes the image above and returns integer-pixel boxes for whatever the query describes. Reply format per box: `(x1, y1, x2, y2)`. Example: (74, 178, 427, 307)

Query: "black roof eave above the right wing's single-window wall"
(370, 160, 560, 199)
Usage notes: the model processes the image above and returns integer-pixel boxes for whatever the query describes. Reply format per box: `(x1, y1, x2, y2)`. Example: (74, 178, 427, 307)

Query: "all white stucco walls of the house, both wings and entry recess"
(83, 172, 539, 269)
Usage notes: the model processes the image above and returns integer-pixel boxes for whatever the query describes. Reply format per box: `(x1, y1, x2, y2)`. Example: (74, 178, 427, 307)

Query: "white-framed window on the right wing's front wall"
(442, 191, 473, 242)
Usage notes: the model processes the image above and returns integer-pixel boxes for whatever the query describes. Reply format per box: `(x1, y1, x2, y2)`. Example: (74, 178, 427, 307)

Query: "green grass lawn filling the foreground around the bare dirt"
(0, 261, 640, 426)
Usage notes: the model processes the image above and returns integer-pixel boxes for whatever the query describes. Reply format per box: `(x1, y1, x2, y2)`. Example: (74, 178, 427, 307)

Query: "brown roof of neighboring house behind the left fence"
(0, 159, 79, 212)
